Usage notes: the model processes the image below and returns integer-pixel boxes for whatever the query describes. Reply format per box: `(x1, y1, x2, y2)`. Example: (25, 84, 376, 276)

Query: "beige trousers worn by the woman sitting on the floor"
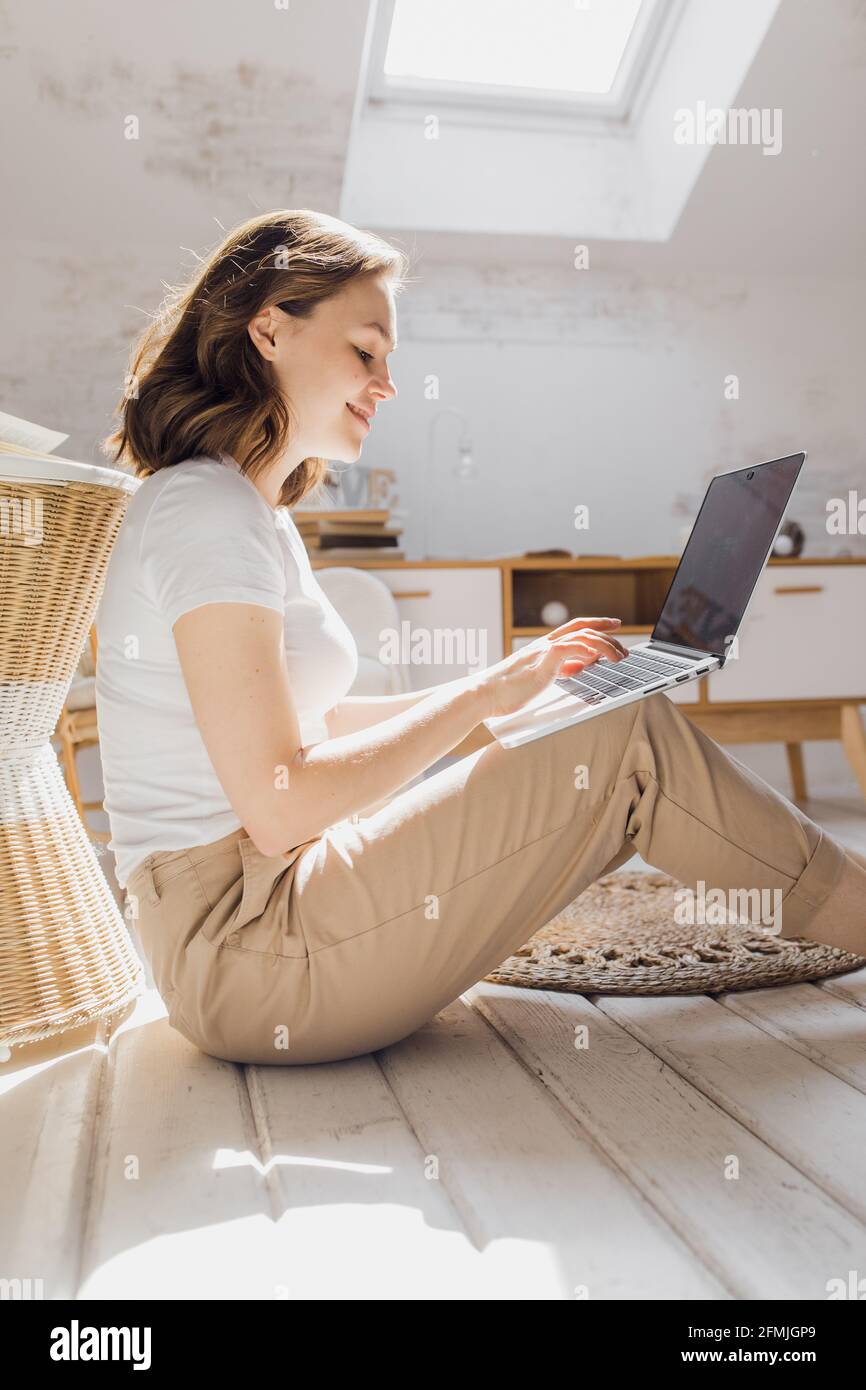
(126, 692, 866, 1065)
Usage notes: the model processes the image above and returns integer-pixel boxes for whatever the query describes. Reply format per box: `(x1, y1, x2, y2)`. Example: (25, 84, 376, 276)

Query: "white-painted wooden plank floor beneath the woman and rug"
(0, 792, 866, 1300)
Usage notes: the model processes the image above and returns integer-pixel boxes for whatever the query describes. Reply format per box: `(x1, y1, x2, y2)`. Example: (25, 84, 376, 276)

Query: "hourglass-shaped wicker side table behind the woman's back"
(0, 455, 145, 1047)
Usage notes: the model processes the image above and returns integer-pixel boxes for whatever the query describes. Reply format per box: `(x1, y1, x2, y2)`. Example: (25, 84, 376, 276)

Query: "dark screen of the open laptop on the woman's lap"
(651, 453, 805, 656)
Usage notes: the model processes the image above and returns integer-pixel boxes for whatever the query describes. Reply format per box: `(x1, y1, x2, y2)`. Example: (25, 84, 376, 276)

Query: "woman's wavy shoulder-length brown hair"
(101, 209, 409, 507)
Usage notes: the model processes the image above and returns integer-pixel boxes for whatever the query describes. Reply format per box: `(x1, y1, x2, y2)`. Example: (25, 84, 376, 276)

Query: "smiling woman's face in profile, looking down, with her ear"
(249, 275, 396, 463)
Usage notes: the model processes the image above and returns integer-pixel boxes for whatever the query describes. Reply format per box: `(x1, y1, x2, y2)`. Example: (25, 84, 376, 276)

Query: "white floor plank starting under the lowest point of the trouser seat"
(247, 1056, 493, 1300)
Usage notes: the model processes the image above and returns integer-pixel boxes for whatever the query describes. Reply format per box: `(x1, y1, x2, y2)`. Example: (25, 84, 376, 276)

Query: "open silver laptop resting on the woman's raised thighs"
(484, 452, 806, 748)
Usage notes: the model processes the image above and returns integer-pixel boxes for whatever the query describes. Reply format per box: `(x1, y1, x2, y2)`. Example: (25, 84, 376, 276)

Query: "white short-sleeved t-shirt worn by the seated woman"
(96, 455, 357, 887)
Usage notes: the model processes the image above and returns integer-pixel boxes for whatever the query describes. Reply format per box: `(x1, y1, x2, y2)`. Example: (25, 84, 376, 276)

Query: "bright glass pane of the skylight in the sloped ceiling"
(384, 0, 646, 96)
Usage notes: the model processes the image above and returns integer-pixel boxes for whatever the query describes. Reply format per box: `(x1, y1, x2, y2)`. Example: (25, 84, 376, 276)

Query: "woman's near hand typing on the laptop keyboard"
(473, 617, 628, 719)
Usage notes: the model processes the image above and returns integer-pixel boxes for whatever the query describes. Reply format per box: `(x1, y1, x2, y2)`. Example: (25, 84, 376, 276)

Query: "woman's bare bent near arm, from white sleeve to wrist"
(172, 602, 493, 855)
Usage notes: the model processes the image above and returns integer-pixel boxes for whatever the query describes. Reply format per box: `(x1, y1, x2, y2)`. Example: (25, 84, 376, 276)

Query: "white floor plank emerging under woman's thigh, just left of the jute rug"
(379, 991, 727, 1300)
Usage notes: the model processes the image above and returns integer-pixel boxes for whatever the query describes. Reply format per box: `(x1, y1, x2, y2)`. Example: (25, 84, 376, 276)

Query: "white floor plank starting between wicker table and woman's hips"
(79, 992, 277, 1300)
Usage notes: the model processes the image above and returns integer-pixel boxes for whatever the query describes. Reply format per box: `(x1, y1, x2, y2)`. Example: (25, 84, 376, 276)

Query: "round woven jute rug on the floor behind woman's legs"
(485, 869, 866, 994)
